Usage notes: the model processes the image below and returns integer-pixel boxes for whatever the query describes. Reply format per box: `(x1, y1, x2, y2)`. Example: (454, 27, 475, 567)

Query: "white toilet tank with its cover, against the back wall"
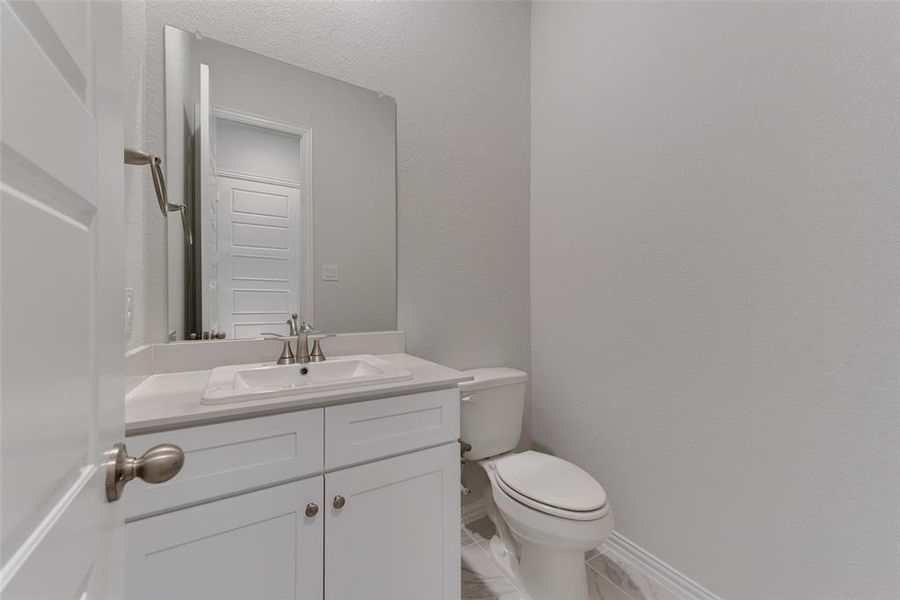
(459, 367, 528, 460)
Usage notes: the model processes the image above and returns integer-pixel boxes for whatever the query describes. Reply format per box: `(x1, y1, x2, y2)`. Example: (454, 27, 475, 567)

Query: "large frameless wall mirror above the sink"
(165, 27, 397, 340)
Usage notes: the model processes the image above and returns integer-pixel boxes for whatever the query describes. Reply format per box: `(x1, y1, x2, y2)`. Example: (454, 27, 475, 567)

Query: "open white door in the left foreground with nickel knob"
(0, 0, 125, 600)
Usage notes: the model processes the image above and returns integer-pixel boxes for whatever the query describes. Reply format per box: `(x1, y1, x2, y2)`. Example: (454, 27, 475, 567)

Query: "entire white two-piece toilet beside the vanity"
(459, 367, 613, 600)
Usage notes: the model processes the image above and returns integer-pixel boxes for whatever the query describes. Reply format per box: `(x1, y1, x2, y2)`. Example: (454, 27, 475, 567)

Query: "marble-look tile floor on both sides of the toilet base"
(460, 517, 646, 600)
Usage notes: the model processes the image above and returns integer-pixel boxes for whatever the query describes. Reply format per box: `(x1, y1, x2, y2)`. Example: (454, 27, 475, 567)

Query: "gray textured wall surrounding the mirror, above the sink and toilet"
(125, 1, 530, 382)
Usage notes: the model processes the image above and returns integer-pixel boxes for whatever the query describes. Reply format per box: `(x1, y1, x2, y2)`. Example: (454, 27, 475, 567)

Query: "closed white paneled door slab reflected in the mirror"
(218, 175, 301, 338)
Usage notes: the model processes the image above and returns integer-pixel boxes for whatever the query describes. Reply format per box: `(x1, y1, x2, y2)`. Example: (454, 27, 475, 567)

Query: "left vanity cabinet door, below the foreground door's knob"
(125, 476, 325, 600)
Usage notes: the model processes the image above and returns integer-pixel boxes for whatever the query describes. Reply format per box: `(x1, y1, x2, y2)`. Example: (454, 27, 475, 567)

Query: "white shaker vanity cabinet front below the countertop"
(123, 388, 460, 600)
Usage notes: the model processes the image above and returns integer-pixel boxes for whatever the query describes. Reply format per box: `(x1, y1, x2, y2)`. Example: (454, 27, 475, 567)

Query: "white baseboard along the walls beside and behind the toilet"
(462, 499, 721, 600)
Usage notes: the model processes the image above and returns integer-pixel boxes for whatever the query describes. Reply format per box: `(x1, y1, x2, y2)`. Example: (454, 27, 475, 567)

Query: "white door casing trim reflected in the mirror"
(213, 106, 316, 323)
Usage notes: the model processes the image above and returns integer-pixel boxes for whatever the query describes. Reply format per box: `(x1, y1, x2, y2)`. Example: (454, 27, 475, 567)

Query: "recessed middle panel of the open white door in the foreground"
(0, 189, 93, 561)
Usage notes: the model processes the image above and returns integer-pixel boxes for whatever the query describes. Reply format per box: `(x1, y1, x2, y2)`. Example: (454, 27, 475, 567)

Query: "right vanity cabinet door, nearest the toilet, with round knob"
(325, 443, 460, 600)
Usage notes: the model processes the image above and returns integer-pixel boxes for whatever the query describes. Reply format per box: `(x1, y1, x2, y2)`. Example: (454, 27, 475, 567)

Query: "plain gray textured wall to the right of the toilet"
(531, 2, 900, 599)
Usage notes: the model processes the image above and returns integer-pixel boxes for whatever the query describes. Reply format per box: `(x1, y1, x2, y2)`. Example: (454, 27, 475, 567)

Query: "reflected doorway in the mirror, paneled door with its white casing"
(209, 111, 314, 338)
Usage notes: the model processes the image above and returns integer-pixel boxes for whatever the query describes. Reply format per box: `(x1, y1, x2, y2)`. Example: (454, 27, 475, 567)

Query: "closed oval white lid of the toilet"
(496, 451, 606, 512)
